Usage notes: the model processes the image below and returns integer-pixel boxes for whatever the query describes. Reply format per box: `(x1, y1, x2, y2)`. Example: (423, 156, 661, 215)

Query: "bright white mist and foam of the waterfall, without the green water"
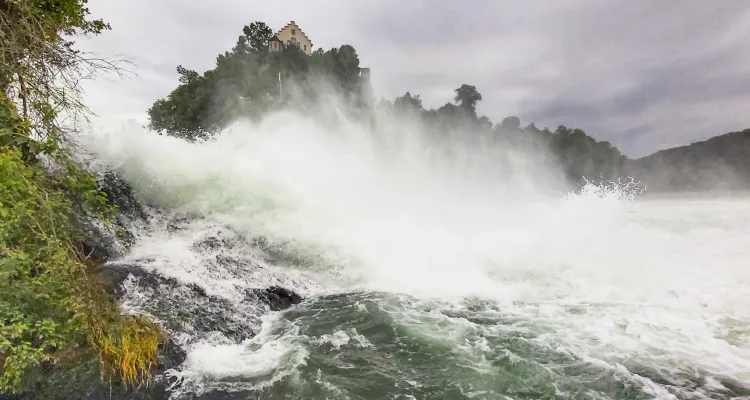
(82, 108, 750, 398)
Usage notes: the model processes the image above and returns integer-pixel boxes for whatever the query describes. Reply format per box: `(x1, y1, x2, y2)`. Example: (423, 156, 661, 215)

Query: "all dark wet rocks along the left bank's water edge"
(0, 172, 303, 400)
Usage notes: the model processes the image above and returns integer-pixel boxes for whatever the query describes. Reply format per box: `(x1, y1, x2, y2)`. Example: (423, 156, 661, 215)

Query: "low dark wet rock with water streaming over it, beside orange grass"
(87, 260, 303, 400)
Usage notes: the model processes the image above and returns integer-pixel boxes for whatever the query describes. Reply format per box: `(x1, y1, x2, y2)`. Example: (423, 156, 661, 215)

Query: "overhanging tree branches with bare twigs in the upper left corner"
(0, 0, 122, 146)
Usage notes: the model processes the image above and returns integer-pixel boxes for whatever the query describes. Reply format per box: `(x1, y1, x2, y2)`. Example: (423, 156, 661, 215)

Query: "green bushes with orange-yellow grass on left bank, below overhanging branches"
(0, 94, 162, 392)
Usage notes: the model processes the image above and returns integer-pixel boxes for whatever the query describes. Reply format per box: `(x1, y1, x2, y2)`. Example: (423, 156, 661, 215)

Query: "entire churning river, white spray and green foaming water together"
(81, 114, 750, 399)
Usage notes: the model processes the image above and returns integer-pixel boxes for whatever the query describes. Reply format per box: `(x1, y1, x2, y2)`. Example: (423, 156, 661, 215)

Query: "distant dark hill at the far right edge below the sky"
(623, 129, 750, 192)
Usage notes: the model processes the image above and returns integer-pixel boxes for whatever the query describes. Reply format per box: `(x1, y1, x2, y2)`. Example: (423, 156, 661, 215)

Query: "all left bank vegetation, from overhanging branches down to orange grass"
(0, 0, 164, 393)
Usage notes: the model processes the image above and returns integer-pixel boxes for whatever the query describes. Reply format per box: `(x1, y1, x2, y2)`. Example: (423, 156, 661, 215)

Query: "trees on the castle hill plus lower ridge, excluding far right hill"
(148, 22, 626, 185)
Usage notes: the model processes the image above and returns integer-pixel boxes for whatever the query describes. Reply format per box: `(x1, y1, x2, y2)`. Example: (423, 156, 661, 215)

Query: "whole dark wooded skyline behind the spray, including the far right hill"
(148, 22, 750, 191)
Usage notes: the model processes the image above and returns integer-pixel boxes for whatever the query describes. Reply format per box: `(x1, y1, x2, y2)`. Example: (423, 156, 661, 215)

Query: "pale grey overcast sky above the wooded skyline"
(76, 0, 750, 157)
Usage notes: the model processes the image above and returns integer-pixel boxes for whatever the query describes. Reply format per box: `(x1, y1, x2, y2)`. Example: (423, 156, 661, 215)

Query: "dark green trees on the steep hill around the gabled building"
(148, 22, 366, 140)
